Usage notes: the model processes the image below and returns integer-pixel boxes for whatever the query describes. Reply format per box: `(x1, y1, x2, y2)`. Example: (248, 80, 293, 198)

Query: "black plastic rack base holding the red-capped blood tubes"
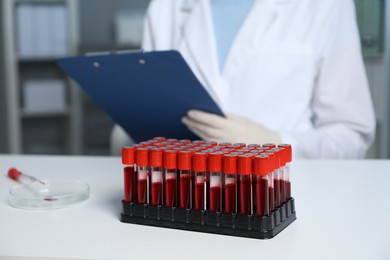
(121, 198, 296, 239)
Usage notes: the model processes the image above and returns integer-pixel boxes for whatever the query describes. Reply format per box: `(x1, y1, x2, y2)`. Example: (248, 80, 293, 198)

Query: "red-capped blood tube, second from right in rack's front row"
(238, 154, 254, 215)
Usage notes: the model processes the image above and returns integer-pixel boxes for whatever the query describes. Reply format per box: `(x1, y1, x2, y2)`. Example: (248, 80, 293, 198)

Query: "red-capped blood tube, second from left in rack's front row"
(135, 148, 150, 204)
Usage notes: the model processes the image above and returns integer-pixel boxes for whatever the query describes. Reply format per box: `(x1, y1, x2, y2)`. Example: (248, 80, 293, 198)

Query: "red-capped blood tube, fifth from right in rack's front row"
(192, 152, 207, 210)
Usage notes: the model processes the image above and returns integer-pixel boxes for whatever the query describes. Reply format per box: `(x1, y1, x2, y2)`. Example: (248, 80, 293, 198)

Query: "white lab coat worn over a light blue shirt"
(143, 0, 375, 158)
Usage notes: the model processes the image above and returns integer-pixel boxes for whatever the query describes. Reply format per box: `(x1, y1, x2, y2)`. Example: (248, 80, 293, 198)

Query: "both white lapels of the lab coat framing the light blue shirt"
(180, 0, 293, 101)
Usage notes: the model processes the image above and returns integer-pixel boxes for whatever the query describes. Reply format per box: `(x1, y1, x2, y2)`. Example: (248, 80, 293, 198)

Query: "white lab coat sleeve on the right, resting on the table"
(281, 0, 375, 159)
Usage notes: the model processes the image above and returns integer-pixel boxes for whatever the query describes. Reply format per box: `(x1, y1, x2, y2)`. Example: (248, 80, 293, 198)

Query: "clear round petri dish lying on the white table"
(8, 180, 89, 210)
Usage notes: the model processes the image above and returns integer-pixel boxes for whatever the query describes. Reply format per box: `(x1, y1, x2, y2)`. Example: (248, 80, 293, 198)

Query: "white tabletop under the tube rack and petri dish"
(0, 155, 390, 260)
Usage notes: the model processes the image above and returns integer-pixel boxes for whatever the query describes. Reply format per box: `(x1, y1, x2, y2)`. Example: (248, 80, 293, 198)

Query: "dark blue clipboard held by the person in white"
(57, 51, 223, 142)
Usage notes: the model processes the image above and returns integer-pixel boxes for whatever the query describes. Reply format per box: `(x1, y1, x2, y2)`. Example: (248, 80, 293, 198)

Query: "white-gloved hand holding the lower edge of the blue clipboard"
(182, 110, 281, 144)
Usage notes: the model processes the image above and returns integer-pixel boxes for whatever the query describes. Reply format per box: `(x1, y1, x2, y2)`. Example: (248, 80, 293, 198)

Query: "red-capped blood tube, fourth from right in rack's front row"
(207, 152, 223, 212)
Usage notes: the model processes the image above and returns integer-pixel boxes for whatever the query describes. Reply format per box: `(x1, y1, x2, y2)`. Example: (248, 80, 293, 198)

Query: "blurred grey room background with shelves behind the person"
(0, 0, 390, 158)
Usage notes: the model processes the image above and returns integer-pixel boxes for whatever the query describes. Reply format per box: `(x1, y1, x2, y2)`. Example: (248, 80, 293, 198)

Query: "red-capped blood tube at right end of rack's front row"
(253, 155, 273, 216)
